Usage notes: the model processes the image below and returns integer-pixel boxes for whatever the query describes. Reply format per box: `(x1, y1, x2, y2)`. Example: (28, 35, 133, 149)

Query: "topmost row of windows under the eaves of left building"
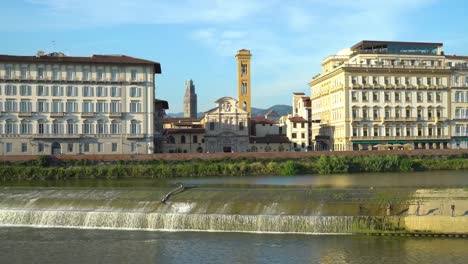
(5, 66, 138, 81)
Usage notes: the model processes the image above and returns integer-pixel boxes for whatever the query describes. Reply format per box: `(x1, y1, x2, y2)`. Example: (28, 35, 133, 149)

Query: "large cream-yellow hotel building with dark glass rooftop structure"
(309, 41, 452, 150)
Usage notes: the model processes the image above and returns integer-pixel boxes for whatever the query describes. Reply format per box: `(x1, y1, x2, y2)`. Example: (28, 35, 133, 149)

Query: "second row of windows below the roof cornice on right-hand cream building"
(351, 91, 442, 103)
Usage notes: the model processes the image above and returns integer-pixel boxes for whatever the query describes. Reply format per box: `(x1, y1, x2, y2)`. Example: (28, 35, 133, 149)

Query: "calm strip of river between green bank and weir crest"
(0, 171, 468, 189)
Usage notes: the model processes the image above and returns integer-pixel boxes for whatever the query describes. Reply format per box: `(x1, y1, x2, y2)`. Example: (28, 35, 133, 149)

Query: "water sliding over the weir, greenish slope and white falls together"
(0, 189, 400, 233)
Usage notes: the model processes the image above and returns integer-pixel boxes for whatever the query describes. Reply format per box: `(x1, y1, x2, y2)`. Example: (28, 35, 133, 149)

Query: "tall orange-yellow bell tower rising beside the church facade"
(236, 49, 252, 117)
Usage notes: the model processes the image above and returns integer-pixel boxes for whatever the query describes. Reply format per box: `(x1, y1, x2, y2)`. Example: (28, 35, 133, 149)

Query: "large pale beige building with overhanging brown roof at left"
(0, 52, 161, 155)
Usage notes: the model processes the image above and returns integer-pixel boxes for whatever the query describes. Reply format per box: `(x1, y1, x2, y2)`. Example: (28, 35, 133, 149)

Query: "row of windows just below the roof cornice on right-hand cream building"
(350, 76, 443, 85)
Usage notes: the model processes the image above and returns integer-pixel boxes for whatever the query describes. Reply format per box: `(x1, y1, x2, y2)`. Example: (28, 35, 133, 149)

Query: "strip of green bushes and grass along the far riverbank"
(0, 153, 468, 181)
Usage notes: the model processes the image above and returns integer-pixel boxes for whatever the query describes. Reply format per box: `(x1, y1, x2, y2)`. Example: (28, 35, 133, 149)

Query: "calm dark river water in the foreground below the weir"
(0, 227, 468, 264)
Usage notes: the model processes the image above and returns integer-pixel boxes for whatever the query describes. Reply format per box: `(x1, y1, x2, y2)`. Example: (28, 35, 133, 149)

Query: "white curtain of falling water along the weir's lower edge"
(0, 210, 402, 233)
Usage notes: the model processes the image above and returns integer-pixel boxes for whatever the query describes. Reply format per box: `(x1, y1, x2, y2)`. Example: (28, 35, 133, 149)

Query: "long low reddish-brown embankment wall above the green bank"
(0, 149, 468, 161)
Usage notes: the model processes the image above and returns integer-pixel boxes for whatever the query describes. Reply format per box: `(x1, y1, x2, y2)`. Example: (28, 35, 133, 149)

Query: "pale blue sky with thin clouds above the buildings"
(0, 0, 468, 113)
